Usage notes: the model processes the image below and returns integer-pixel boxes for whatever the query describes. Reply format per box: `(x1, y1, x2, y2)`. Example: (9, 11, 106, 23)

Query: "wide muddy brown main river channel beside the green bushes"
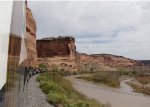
(67, 76, 150, 107)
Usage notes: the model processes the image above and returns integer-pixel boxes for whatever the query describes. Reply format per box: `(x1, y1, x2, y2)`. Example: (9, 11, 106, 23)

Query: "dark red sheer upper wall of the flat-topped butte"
(37, 37, 76, 58)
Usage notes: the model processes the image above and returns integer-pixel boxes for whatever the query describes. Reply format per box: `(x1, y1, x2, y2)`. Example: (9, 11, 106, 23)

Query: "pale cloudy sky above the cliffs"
(28, 1, 150, 60)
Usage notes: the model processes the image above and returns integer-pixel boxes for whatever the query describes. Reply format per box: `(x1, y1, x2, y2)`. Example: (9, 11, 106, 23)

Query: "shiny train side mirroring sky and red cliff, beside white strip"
(5, 1, 27, 107)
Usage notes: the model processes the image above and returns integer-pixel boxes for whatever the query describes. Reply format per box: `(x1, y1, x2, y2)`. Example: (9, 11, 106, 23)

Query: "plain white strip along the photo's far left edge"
(0, 1, 13, 90)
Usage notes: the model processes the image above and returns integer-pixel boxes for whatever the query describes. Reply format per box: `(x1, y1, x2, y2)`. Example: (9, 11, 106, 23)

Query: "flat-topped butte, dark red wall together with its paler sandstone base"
(37, 36, 77, 71)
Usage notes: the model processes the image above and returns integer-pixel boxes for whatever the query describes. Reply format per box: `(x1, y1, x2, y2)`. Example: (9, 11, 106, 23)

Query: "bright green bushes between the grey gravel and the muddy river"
(37, 72, 102, 107)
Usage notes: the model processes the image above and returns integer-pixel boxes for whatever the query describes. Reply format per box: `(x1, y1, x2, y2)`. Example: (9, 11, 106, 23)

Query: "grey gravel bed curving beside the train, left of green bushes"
(22, 75, 53, 107)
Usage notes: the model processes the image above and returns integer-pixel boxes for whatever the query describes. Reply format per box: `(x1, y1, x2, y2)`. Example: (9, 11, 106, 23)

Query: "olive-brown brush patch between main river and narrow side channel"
(78, 72, 120, 88)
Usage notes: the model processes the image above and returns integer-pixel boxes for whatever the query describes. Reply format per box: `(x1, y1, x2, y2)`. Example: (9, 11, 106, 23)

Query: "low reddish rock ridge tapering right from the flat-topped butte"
(78, 54, 143, 67)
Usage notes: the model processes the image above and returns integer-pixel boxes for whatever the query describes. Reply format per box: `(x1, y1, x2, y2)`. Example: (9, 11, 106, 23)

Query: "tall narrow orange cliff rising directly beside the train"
(26, 6, 37, 67)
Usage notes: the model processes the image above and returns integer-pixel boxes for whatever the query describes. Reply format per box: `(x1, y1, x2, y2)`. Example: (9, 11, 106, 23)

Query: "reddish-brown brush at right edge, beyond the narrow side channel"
(118, 68, 150, 95)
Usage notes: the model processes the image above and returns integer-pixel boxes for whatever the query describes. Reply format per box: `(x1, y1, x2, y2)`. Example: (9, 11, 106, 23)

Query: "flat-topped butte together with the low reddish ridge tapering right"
(37, 37, 143, 71)
